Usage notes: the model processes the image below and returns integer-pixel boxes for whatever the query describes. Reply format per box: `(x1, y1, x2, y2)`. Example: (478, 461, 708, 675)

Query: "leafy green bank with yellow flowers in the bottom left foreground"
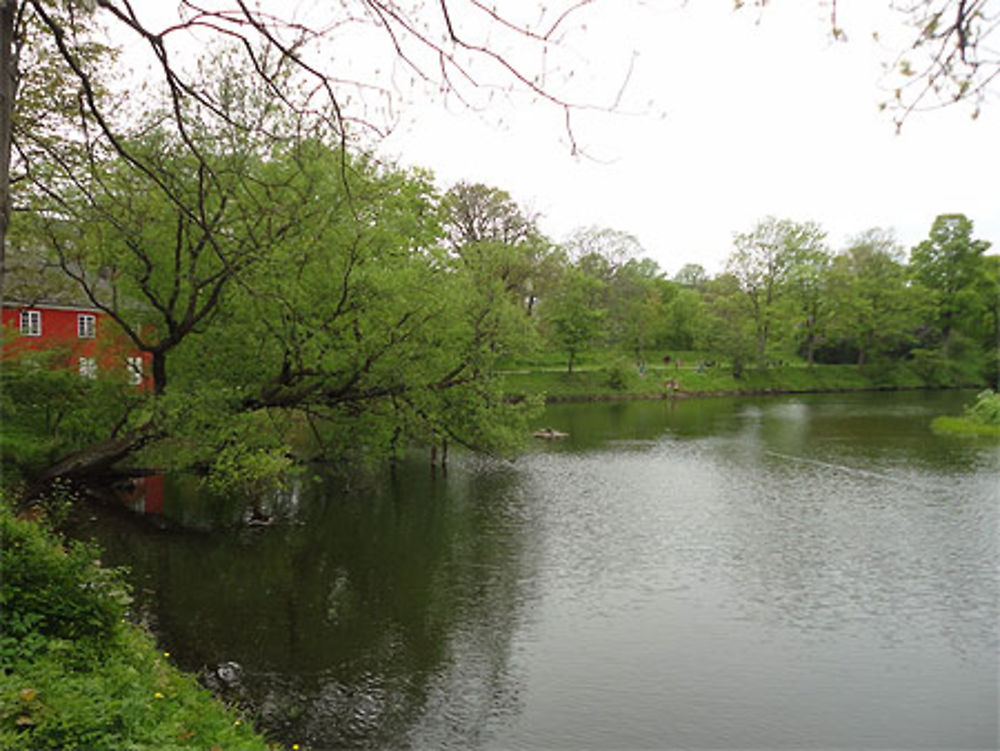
(0, 500, 268, 751)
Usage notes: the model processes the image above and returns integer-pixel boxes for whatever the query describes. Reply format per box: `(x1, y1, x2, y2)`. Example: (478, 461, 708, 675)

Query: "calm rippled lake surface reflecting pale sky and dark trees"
(72, 392, 1000, 749)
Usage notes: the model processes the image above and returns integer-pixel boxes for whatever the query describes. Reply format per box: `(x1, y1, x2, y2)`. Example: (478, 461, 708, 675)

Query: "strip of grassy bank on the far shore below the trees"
(504, 362, 924, 401)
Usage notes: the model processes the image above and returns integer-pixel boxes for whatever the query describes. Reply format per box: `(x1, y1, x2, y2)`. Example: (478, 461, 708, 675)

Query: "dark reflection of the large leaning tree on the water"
(79, 457, 536, 748)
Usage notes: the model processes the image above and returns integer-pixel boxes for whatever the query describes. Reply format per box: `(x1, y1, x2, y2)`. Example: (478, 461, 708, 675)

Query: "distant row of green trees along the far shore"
(445, 185, 1000, 386)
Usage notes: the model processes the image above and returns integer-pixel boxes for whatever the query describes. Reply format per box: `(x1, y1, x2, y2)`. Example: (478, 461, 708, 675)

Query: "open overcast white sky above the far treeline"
(382, 0, 1000, 274)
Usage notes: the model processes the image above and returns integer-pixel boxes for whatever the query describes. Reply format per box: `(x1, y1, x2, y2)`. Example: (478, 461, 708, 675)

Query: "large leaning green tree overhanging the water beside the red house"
(7, 132, 544, 486)
